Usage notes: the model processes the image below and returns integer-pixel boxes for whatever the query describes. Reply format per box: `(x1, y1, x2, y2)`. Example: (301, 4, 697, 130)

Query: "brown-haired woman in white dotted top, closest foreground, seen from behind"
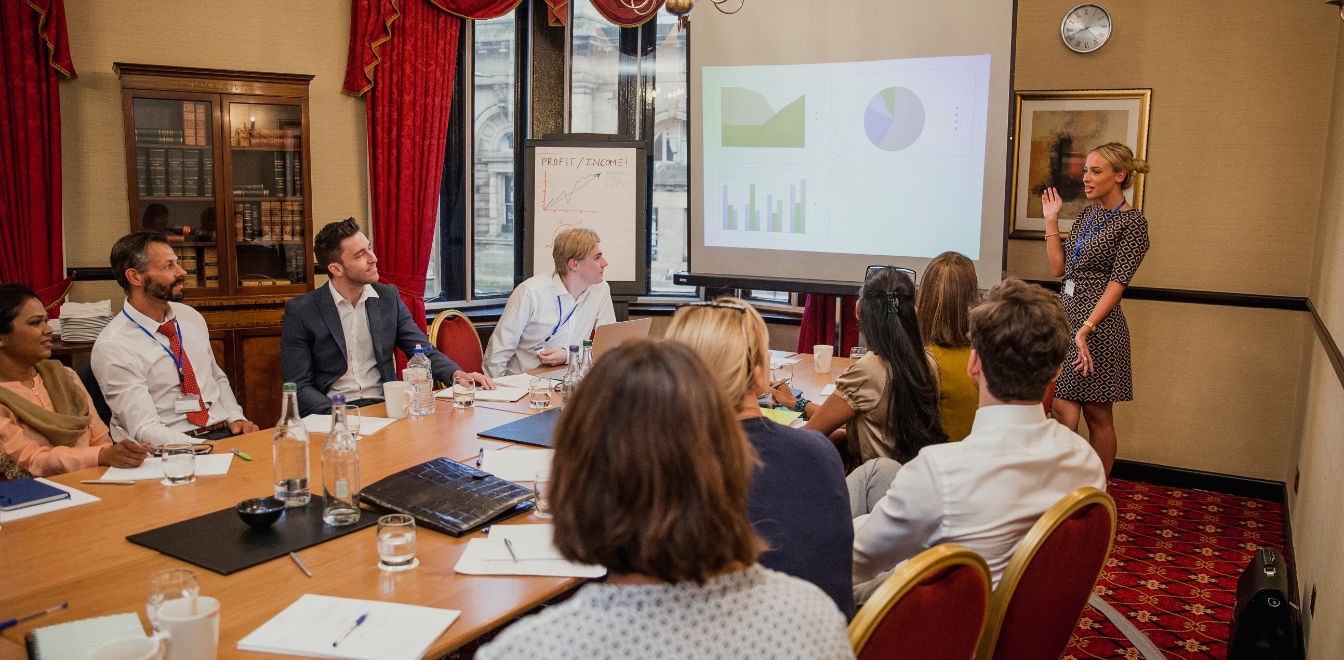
(476, 340, 853, 660)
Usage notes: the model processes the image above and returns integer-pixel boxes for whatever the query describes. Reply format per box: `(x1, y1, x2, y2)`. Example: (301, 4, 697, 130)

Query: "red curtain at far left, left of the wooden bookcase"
(0, 0, 75, 293)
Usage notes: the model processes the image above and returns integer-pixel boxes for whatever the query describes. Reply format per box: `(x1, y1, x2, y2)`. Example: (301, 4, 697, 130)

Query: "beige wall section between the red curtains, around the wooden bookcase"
(60, 0, 368, 304)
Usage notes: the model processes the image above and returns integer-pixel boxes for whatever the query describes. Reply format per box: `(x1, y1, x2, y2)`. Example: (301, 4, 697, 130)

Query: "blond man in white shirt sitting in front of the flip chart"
(485, 229, 616, 378)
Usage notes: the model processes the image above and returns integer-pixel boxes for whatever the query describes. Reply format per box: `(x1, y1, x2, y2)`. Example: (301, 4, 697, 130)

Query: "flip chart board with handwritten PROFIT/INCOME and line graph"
(524, 140, 648, 294)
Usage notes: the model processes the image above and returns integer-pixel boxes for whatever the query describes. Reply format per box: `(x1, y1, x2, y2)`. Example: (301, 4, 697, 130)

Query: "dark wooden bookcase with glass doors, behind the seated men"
(113, 62, 313, 426)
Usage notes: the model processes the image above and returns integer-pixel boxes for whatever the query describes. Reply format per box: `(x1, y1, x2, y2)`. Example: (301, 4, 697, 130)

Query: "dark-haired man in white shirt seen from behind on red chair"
(853, 278, 1106, 602)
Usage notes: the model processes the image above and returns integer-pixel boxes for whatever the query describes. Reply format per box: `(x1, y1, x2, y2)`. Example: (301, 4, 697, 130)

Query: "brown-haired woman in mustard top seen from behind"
(915, 253, 980, 442)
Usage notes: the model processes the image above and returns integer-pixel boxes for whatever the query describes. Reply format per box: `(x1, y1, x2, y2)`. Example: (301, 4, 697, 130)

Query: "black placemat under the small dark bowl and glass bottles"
(126, 497, 379, 575)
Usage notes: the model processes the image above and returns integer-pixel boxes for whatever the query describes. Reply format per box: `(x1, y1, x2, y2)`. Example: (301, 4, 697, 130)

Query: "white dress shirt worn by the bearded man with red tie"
(89, 300, 246, 446)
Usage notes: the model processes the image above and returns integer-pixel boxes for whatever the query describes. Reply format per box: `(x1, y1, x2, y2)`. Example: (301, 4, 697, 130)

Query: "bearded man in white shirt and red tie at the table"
(90, 231, 257, 446)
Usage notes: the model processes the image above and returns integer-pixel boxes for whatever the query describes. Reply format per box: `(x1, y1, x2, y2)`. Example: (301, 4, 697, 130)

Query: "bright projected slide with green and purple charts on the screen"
(700, 55, 989, 259)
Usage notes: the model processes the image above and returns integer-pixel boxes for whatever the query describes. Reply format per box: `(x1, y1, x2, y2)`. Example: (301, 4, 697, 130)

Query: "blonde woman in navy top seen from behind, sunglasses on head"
(664, 297, 853, 617)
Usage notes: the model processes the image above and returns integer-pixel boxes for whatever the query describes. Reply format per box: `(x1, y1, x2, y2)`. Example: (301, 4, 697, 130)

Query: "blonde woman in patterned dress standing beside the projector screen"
(1040, 142, 1148, 475)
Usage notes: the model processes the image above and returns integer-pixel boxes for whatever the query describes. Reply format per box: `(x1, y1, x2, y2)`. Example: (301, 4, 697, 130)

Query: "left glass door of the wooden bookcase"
(132, 97, 219, 289)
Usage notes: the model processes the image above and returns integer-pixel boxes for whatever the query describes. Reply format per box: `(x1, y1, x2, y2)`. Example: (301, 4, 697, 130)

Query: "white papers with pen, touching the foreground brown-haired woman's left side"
(453, 524, 606, 578)
